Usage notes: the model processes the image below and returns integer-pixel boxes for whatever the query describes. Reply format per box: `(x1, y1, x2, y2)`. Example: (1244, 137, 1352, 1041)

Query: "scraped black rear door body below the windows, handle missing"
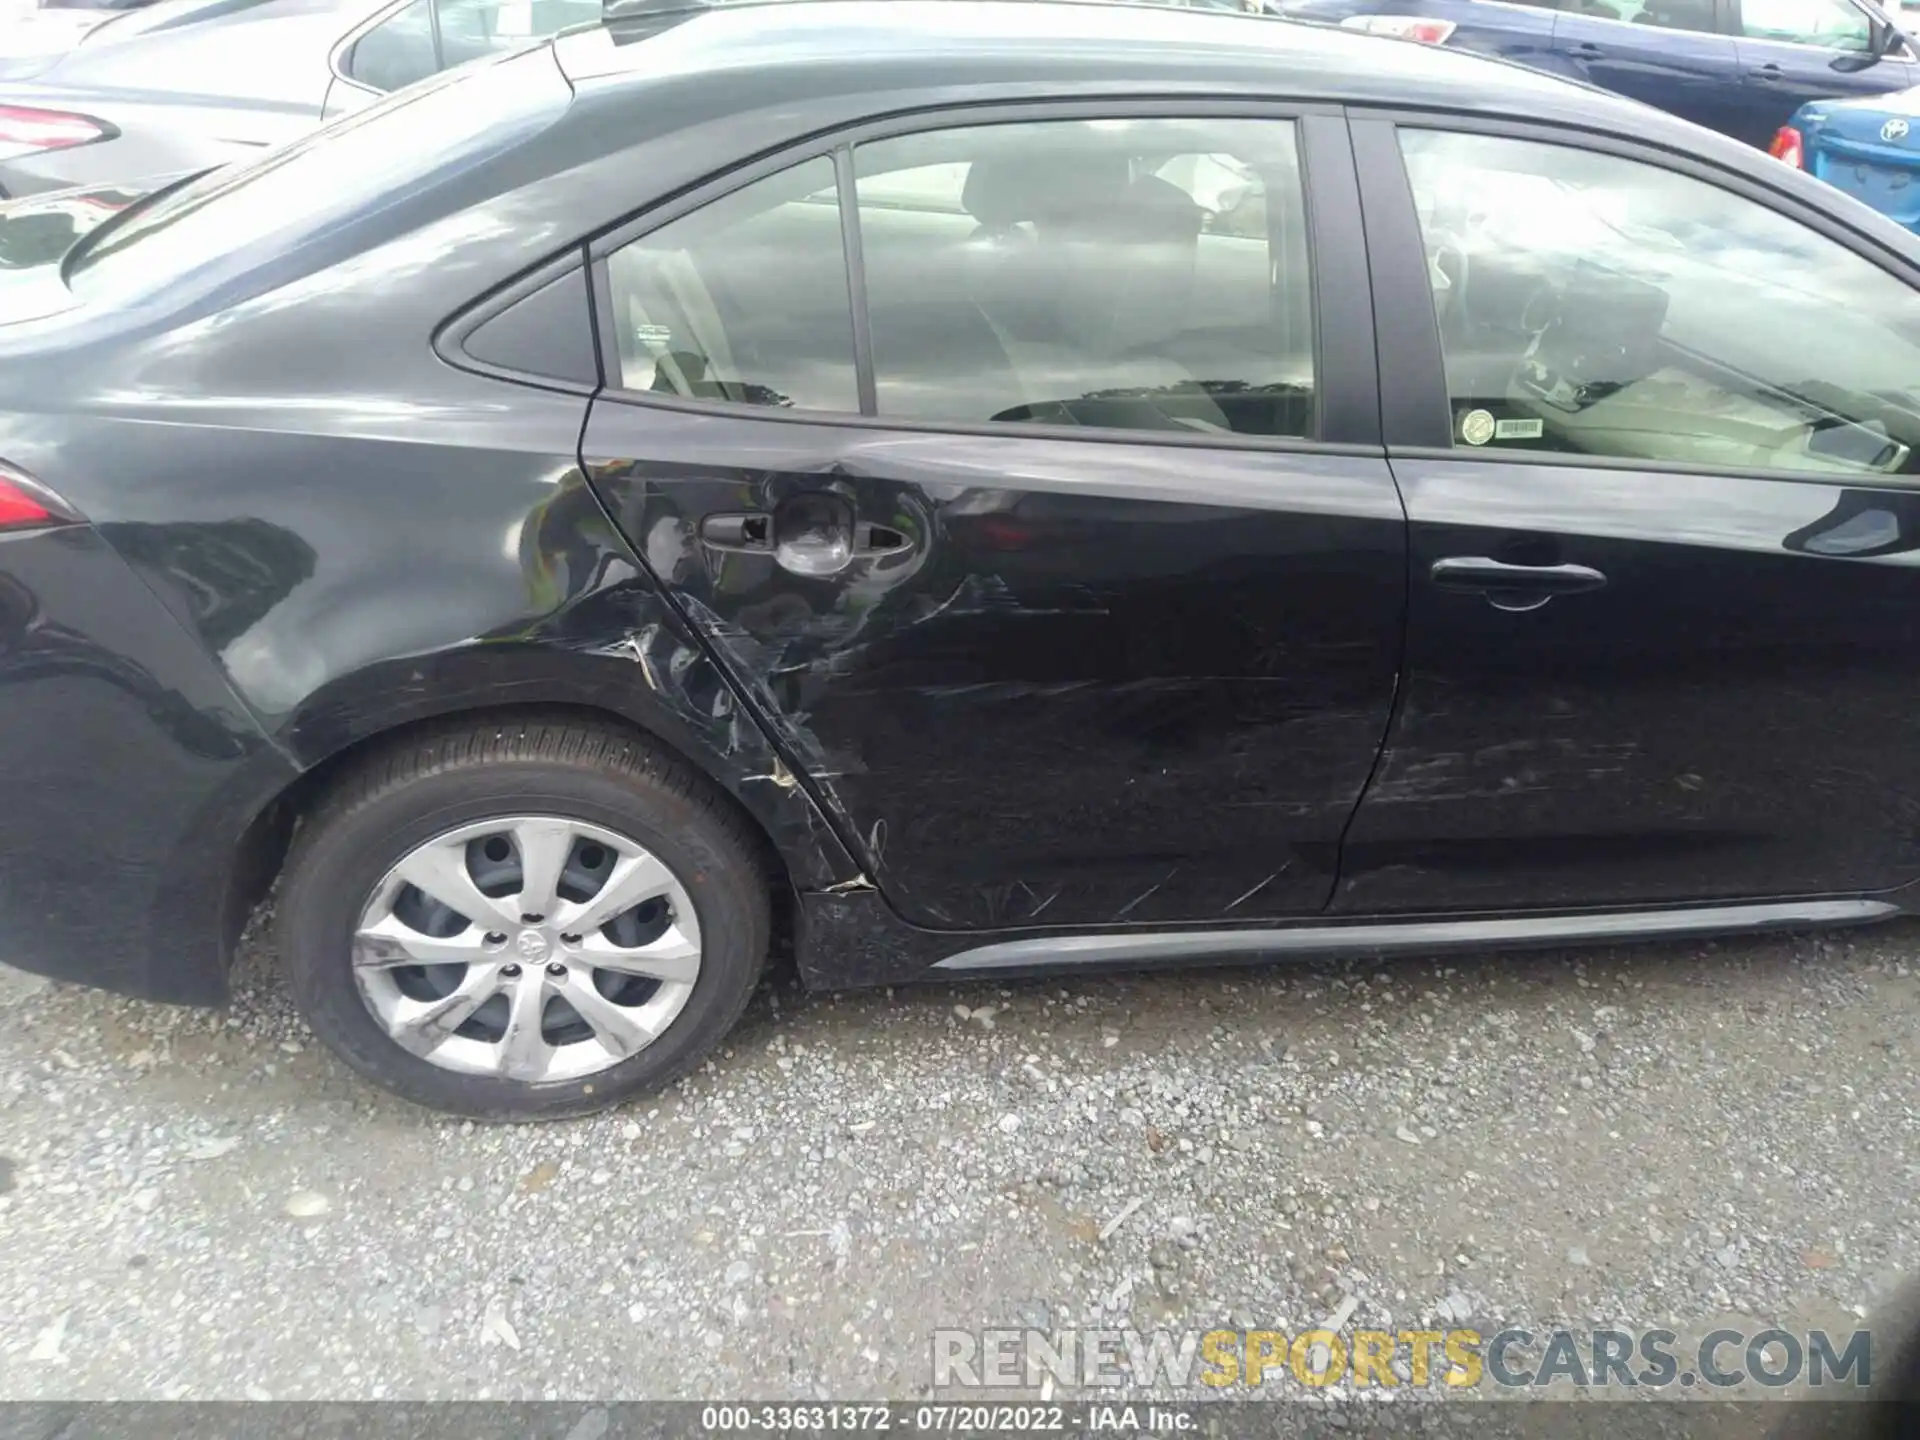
(586, 399, 1405, 927)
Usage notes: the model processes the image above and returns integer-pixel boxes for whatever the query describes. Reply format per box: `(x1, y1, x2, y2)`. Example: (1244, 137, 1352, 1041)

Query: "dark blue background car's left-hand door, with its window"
(1553, 0, 1741, 132)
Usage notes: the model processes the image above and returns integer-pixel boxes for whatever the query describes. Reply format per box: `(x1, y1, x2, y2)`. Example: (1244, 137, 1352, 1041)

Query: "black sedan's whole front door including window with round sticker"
(1336, 123, 1920, 912)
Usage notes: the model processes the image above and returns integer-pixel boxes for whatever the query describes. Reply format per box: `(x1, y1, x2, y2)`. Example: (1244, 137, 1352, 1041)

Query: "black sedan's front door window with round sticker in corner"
(1402, 131, 1920, 480)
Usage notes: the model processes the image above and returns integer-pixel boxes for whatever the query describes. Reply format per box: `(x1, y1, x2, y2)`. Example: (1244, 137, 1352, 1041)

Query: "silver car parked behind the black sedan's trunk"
(0, 0, 601, 198)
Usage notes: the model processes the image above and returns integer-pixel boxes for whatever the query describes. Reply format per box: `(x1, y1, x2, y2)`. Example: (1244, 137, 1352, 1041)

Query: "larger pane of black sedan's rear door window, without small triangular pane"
(854, 119, 1313, 436)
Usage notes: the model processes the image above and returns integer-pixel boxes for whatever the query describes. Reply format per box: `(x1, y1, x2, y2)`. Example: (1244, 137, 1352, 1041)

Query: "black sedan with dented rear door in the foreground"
(11, 0, 1920, 1117)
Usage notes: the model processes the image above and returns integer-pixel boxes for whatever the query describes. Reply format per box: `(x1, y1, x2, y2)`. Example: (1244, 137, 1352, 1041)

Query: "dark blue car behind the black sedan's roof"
(1273, 0, 1920, 148)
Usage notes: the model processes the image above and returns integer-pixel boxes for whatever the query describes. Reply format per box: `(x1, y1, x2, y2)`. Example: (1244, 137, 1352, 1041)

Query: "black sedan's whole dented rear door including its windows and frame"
(584, 102, 1405, 927)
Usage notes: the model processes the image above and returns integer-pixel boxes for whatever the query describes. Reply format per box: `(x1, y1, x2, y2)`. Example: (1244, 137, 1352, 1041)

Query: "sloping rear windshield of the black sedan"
(65, 50, 572, 301)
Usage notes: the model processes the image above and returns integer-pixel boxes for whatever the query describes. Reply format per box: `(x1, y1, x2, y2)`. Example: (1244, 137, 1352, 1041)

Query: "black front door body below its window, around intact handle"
(1334, 459, 1920, 914)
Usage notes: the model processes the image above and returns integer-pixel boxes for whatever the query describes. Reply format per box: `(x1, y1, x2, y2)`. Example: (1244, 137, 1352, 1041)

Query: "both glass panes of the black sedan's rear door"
(607, 119, 1315, 438)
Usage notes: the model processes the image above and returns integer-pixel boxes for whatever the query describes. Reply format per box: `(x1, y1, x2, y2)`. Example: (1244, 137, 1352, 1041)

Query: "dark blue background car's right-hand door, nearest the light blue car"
(1730, 0, 1920, 146)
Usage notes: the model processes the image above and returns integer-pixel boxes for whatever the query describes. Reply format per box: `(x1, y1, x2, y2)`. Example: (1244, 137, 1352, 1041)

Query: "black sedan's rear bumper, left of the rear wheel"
(0, 528, 294, 1004)
